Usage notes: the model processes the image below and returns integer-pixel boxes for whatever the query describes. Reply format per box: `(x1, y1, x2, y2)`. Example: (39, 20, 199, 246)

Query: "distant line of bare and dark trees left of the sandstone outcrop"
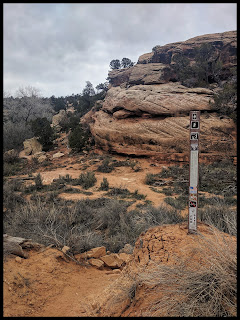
(3, 81, 108, 151)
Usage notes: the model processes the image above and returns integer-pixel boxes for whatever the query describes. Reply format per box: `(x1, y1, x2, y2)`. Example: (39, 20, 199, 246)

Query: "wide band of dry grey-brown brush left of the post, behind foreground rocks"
(3, 192, 186, 252)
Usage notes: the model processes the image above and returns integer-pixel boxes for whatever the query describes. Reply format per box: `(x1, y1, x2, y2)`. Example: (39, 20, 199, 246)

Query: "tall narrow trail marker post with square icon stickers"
(188, 111, 200, 233)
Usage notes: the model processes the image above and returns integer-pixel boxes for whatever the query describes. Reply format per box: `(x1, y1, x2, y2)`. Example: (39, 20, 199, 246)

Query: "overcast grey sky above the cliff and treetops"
(3, 3, 237, 97)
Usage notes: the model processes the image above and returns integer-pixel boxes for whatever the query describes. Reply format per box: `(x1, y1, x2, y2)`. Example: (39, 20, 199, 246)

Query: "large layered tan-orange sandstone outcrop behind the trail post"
(82, 31, 237, 161)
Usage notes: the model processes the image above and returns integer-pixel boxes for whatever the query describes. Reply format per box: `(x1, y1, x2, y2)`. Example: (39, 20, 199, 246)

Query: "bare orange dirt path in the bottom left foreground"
(3, 248, 119, 317)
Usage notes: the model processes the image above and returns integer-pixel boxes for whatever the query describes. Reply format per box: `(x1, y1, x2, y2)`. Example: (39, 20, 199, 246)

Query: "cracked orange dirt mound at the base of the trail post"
(96, 222, 236, 317)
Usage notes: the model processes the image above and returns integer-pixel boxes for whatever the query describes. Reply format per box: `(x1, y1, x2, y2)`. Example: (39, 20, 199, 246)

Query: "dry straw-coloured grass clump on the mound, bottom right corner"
(138, 231, 237, 317)
